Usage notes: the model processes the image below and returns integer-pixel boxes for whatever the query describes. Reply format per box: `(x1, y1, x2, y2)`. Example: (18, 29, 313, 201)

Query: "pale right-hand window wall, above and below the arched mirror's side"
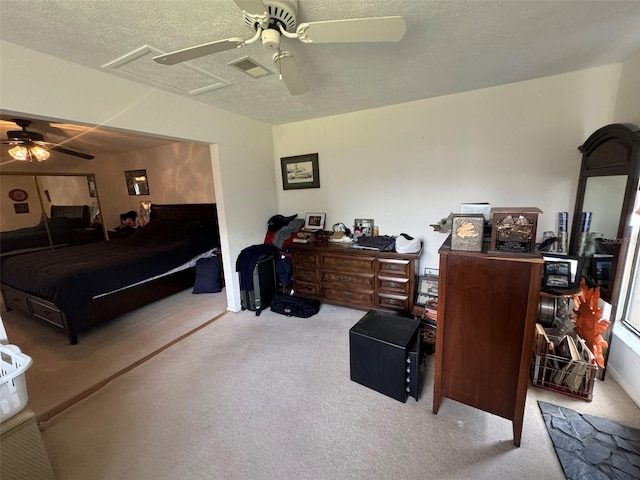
(607, 51, 640, 405)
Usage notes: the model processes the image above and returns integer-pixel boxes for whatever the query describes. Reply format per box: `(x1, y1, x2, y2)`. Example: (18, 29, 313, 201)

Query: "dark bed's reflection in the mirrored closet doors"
(0, 205, 91, 253)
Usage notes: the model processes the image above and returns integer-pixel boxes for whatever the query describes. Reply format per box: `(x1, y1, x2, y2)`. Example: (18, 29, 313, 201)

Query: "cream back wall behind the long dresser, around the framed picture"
(273, 65, 620, 267)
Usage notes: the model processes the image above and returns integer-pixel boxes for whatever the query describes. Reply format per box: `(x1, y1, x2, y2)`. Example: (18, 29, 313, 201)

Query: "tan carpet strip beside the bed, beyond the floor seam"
(2, 289, 227, 421)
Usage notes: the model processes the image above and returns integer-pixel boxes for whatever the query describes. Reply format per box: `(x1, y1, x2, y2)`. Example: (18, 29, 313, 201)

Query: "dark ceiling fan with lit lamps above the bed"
(2, 118, 95, 162)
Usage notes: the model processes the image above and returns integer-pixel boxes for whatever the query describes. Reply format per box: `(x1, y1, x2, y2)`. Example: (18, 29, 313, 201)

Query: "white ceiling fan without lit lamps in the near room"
(153, 0, 407, 95)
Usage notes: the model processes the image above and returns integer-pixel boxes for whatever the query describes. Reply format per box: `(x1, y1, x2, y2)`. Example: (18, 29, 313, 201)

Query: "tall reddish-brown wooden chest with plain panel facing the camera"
(433, 241, 544, 446)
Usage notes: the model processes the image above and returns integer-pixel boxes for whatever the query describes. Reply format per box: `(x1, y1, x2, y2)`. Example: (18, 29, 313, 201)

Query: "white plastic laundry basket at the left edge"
(0, 345, 33, 423)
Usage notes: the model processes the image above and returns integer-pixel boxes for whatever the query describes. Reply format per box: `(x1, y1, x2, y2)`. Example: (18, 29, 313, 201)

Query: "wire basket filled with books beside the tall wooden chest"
(531, 323, 598, 401)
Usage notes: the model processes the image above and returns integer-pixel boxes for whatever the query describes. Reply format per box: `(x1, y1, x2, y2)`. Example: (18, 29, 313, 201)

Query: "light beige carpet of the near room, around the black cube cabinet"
(38, 305, 640, 480)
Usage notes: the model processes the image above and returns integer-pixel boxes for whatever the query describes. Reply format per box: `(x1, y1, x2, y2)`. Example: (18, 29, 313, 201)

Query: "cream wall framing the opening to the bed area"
(0, 41, 277, 311)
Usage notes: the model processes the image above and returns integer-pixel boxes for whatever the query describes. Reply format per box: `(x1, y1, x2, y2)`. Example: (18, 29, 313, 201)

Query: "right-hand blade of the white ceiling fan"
(297, 16, 407, 43)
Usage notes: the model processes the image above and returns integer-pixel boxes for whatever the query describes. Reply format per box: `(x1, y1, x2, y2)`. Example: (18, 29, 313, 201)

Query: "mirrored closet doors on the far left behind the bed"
(0, 172, 107, 254)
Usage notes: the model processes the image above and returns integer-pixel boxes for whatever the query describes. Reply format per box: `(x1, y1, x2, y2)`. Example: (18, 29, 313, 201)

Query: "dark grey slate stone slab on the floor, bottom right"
(538, 401, 640, 480)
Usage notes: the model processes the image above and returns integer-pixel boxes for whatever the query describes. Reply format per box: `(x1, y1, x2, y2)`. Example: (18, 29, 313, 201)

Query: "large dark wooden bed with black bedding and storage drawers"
(0, 204, 220, 345)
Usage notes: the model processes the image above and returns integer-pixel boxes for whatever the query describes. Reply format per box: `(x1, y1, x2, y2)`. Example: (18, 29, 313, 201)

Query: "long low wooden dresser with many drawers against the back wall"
(292, 244, 420, 315)
